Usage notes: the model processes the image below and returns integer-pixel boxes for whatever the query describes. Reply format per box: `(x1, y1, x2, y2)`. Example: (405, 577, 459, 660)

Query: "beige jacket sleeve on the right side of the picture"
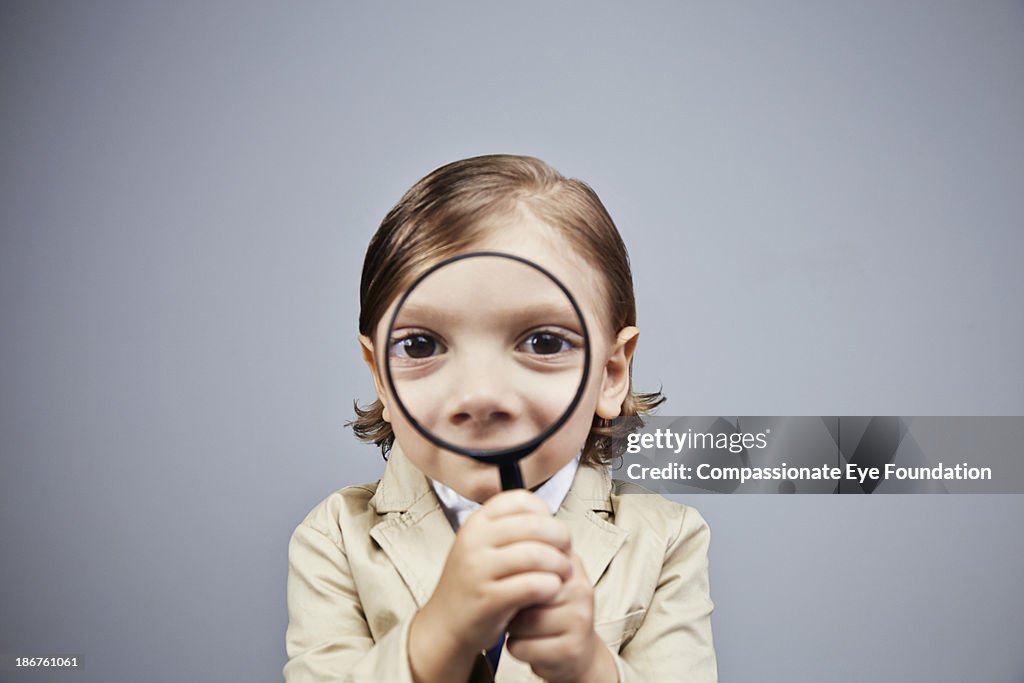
(613, 507, 718, 683)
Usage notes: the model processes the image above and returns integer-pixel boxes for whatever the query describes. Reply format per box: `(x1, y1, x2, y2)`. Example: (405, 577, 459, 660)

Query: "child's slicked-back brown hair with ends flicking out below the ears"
(349, 155, 665, 465)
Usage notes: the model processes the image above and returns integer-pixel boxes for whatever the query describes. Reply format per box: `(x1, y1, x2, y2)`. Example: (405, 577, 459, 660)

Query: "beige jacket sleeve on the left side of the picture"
(284, 522, 413, 683)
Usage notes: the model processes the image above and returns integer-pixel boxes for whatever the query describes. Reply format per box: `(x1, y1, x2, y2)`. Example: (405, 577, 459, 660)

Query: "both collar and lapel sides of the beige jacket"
(370, 444, 628, 607)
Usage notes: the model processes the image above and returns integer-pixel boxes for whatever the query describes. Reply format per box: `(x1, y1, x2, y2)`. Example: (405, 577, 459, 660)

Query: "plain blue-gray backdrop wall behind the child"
(0, 1, 1024, 682)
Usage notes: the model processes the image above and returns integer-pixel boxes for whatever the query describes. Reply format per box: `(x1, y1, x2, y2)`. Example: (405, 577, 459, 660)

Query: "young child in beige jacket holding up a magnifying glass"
(285, 156, 717, 683)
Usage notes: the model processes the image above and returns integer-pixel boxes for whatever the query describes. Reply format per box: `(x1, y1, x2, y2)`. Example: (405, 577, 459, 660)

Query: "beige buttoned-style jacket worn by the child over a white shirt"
(284, 449, 717, 683)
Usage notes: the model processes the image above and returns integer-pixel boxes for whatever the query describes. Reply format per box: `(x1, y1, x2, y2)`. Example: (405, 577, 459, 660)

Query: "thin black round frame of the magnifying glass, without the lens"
(383, 251, 591, 490)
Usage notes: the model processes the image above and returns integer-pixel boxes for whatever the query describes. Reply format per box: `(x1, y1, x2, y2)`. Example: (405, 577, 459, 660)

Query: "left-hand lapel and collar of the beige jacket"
(370, 445, 455, 607)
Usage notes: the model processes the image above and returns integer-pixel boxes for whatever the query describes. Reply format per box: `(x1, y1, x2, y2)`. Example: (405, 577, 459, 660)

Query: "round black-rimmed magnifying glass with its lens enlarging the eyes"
(381, 251, 591, 490)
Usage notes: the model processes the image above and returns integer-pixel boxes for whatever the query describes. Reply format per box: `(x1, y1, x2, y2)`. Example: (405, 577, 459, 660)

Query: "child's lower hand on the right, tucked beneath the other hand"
(507, 555, 618, 683)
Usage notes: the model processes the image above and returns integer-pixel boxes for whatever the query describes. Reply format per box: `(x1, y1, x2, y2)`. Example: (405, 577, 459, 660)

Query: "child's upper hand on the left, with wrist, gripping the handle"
(409, 489, 573, 681)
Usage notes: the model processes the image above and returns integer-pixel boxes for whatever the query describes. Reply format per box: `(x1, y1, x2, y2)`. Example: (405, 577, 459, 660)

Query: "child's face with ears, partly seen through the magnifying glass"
(360, 212, 636, 502)
